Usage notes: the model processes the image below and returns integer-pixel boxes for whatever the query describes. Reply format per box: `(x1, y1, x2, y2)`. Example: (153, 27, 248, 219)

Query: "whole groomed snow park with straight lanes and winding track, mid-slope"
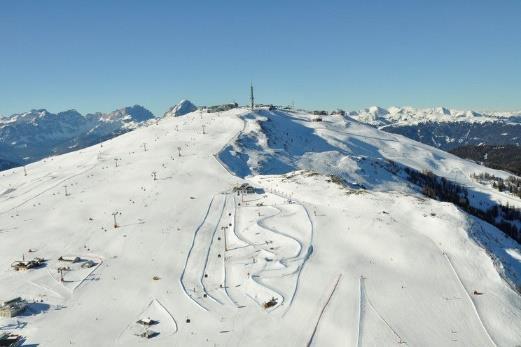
(180, 188, 312, 318)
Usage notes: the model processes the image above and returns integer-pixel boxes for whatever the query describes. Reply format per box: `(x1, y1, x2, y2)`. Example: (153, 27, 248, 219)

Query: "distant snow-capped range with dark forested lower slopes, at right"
(349, 106, 521, 150)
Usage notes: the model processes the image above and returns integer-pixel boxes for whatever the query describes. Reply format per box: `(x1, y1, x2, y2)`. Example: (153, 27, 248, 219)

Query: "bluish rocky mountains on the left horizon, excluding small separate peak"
(0, 105, 154, 165)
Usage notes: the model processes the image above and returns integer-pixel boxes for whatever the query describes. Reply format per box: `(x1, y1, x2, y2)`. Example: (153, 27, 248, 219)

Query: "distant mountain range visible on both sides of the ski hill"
(0, 100, 521, 174)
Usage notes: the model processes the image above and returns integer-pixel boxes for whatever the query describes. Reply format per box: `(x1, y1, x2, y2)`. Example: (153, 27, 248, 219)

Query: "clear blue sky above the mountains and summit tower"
(0, 0, 521, 115)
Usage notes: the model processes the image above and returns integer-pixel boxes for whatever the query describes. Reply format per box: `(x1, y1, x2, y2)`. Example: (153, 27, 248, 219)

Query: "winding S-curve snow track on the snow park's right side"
(230, 193, 312, 312)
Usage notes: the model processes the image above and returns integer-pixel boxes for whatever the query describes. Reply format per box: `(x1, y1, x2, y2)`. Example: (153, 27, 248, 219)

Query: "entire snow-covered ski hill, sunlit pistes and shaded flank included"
(0, 109, 521, 346)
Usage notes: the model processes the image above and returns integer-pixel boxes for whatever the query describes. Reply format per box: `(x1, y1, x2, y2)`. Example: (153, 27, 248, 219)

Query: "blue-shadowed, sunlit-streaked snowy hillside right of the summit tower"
(217, 110, 515, 197)
